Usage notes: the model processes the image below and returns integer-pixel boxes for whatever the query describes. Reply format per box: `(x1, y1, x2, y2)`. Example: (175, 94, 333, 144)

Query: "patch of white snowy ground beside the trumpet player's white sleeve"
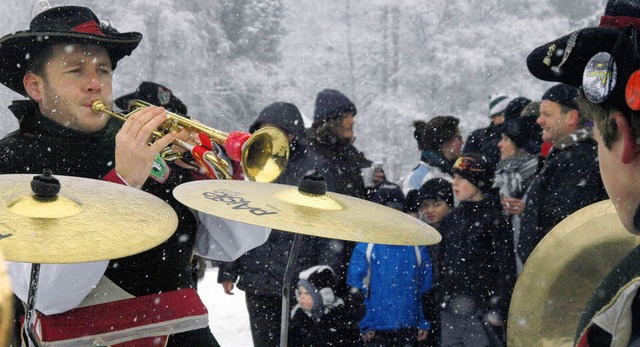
(198, 264, 253, 347)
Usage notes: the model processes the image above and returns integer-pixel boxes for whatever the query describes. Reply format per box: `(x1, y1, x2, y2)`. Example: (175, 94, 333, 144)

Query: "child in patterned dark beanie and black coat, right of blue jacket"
(439, 153, 516, 346)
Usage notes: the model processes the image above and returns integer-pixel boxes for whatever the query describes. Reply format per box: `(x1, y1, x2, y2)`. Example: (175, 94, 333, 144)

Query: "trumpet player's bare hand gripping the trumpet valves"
(115, 106, 177, 188)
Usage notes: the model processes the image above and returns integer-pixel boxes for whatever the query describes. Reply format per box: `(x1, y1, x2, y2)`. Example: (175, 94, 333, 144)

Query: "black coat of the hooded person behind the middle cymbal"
(218, 144, 340, 297)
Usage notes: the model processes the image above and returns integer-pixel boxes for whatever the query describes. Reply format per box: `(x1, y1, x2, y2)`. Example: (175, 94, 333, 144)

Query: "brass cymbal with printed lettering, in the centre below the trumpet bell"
(173, 180, 441, 245)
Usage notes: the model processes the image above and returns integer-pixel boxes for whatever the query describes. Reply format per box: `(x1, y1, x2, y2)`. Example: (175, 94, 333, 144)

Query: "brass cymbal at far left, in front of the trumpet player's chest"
(0, 174, 178, 264)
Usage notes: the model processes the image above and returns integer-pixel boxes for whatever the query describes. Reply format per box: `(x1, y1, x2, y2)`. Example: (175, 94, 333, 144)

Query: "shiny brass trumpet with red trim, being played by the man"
(91, 100, 289, 182)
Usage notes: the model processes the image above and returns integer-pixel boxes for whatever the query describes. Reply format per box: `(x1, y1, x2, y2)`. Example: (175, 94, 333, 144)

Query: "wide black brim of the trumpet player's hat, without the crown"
(0, 31, 142, 96)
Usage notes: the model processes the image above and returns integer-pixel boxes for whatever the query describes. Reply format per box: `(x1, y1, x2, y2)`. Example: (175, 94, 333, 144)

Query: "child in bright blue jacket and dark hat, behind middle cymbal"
(347, 182, 433, 346)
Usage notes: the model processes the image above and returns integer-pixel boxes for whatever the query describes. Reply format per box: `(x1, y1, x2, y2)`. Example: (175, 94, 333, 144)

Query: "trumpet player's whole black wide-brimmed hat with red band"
(0, 6, 142, 96)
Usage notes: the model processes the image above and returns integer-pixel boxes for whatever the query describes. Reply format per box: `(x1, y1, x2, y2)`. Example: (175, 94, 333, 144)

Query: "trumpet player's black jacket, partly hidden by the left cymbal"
(0, 100, 197, 296)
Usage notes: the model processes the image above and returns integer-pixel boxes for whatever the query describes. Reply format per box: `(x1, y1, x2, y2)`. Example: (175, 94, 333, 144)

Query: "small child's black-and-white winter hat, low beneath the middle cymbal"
(297, 265, 336, 311)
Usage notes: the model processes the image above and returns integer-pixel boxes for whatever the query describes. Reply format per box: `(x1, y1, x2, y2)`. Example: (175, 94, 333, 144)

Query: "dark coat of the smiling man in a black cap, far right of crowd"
(518, 129, 608, 262)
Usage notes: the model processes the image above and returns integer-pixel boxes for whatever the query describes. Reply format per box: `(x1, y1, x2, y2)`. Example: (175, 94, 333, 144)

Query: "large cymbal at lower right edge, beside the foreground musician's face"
(507, 200, 640, 347)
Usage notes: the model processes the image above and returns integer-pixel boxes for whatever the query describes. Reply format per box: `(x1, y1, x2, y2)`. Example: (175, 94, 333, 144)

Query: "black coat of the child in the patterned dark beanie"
(440, 191, 516, 318)
